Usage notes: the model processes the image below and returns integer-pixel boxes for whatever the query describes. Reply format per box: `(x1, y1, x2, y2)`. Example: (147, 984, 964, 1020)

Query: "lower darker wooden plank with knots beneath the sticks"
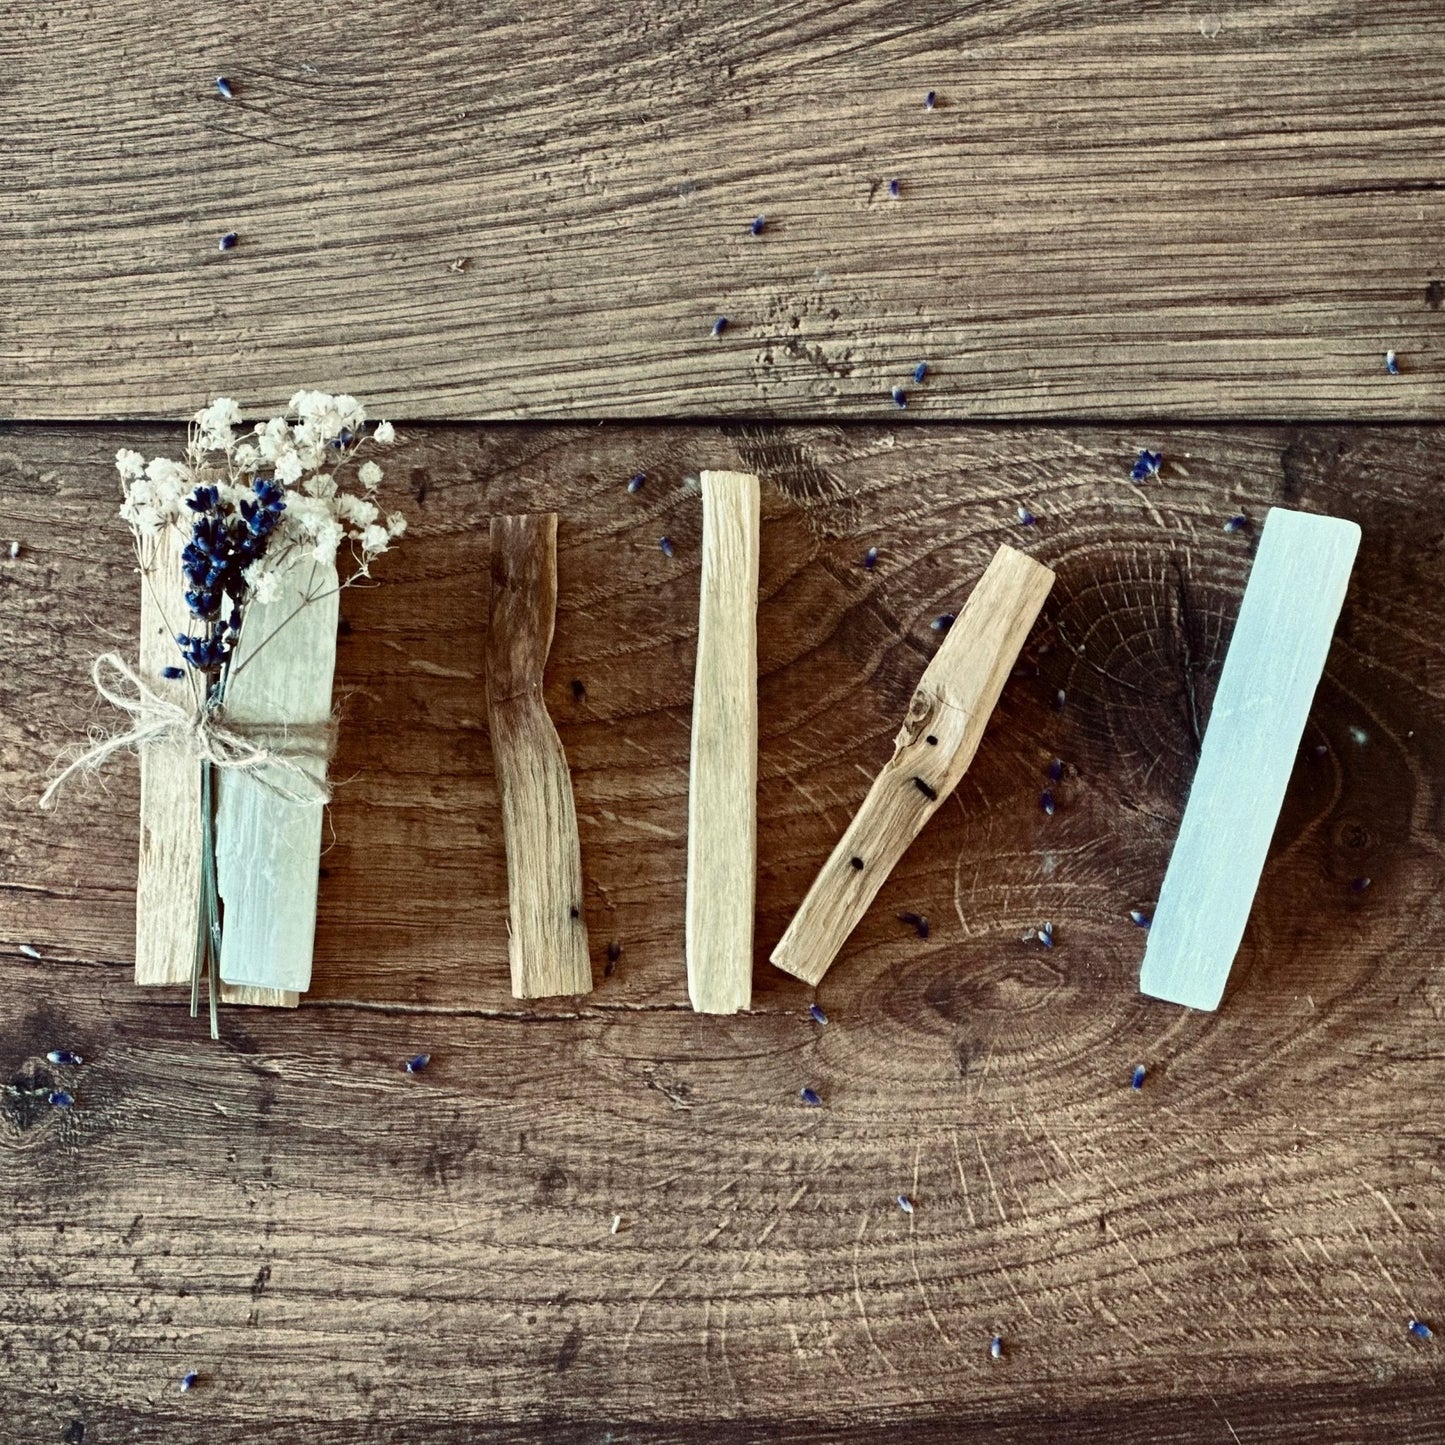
(0, 426, 1445, 1445)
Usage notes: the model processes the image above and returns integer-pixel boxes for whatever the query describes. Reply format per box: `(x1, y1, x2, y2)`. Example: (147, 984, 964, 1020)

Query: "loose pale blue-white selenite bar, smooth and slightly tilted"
(1139, 507, 1360, 1009)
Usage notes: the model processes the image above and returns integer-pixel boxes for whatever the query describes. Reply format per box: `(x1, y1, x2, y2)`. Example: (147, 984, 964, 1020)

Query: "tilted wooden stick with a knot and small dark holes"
(773, 546, 1053, 984)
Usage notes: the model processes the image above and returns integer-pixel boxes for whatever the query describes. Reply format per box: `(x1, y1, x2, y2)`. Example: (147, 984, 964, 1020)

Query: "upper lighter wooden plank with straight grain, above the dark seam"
(0, 0, 1445, 419)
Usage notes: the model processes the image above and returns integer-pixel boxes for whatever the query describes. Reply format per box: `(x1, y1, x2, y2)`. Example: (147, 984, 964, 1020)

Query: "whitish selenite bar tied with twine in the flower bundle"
(215, 553, 340, 1003)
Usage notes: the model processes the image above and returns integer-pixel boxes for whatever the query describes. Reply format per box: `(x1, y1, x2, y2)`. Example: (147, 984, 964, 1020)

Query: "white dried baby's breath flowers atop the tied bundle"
(116, 392, 406, 586)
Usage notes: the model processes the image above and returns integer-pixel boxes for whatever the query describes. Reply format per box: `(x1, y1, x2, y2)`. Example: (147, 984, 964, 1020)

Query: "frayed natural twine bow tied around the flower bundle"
(40, 652, 334, 808)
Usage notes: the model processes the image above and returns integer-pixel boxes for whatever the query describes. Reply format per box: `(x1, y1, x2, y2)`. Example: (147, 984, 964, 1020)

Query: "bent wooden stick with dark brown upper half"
(487, 512, 592, 998)
